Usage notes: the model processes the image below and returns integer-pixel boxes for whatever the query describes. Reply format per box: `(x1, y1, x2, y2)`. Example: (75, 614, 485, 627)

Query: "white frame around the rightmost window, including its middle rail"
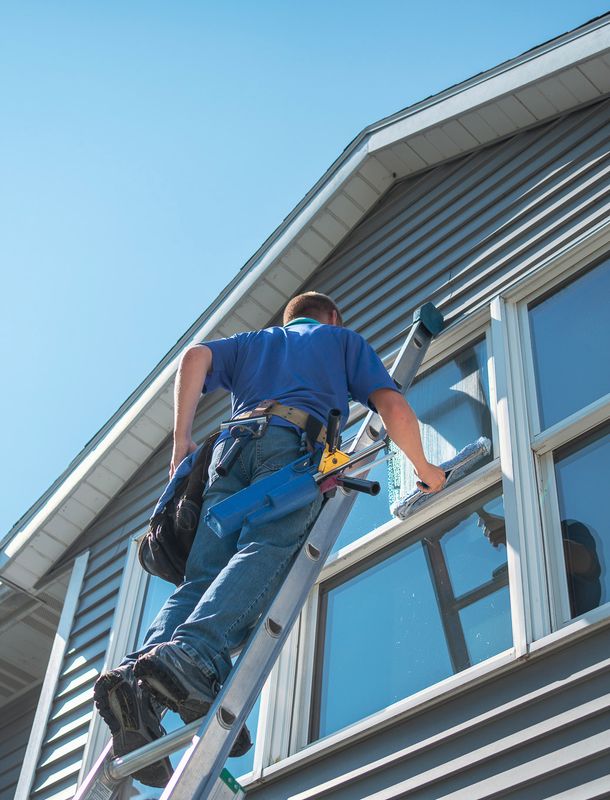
(492, 222, 610, 646)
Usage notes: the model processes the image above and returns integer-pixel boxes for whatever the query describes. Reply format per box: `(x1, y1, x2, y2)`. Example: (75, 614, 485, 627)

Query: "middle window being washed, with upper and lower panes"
(308, 338, 504, 741)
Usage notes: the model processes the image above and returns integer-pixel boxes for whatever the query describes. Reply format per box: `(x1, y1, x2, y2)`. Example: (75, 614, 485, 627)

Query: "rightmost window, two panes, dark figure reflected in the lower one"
(524, 258, 610, 627)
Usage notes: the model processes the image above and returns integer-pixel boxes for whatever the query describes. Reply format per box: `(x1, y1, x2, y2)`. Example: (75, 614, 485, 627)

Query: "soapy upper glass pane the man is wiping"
(333, 341, 491, 552)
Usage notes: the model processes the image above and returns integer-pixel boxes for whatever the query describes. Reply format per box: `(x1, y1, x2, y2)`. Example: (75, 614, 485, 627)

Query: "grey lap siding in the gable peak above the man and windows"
(305, 101, 610, 354)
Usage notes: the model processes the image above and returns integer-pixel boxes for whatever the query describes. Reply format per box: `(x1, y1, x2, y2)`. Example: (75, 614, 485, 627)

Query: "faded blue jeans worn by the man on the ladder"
(123, 425, 322, 683)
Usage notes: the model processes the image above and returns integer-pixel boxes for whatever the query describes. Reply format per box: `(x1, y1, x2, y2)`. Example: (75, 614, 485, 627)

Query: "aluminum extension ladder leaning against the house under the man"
(74, 303, 443, 800)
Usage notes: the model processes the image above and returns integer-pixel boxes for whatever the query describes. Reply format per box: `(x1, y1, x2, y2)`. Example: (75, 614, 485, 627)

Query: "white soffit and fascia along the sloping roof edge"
(0, 15, 610, 591)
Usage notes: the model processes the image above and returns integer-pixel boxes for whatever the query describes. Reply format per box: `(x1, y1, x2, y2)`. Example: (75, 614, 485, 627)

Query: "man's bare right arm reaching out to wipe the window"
(370, 389, 445, 494)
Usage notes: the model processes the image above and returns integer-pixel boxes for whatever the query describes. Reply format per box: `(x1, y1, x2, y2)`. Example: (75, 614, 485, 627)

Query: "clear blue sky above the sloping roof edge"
(0, 0, 608, 536)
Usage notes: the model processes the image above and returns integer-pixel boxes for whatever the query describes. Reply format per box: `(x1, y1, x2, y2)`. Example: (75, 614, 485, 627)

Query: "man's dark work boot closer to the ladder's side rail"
(134, 642, 252, 758)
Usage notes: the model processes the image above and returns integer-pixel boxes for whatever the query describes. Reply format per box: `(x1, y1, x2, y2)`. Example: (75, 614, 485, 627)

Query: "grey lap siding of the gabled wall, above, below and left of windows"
(17, 100, 610, 800)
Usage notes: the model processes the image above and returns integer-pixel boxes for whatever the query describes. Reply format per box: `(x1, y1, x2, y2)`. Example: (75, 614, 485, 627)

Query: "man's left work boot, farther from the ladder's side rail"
(93, 664, 173, 788)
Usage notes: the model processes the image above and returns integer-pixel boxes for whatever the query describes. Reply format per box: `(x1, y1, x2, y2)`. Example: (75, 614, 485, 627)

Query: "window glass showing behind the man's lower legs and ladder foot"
(129, 576, 260, 800)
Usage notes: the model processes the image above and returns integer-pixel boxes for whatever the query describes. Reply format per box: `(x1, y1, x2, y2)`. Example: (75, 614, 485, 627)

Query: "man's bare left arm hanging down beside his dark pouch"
(169, 345, 212, 478)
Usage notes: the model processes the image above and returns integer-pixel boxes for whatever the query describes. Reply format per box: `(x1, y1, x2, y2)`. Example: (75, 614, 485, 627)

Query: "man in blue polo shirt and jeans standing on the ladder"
(94, 292, 445, 786)
